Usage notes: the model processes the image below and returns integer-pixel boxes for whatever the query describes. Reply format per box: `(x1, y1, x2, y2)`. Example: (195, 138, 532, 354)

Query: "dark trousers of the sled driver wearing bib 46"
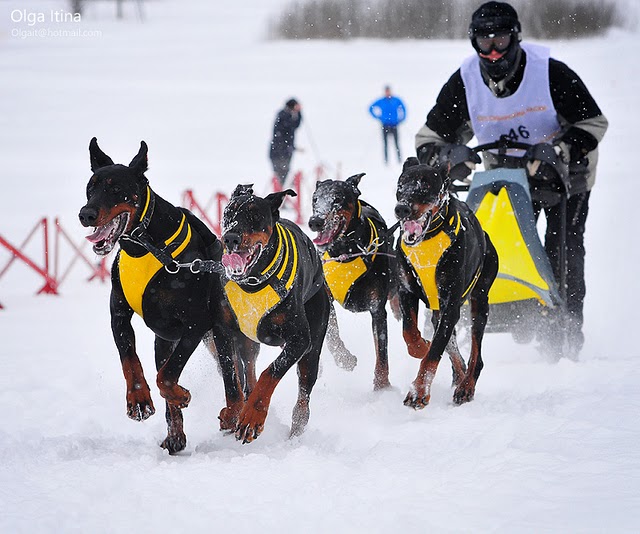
(534, 191, 591, 340)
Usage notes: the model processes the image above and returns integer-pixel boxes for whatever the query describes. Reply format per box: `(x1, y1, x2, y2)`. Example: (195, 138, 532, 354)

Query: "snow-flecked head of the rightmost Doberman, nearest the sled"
(395, 158, 449, 245)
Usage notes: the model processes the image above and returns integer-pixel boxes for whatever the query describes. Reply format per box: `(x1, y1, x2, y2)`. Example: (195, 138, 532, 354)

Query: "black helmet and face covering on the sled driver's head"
(469, 2, 522, 80)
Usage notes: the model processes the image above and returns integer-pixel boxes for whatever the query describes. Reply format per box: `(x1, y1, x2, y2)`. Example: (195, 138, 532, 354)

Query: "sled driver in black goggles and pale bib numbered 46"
(416, 1, 608, 360)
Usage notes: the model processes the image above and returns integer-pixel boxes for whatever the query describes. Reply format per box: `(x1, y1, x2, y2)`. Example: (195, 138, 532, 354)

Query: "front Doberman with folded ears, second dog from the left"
(222, 185, 331, 443)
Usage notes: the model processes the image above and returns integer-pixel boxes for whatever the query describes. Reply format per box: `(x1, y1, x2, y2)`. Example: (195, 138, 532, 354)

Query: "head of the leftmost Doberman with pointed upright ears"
(79, 137, 149, 256)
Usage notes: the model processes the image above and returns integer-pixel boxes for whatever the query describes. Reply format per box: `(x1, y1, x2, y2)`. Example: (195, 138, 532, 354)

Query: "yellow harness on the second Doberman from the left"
(224, 223, 298, 341)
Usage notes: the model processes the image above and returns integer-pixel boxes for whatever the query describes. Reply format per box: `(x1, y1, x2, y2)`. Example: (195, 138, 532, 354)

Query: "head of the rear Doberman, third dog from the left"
(309, 173, 365, 251)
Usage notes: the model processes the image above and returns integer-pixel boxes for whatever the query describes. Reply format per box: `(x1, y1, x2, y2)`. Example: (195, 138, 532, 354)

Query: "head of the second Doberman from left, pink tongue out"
(222, 185, 296, 281)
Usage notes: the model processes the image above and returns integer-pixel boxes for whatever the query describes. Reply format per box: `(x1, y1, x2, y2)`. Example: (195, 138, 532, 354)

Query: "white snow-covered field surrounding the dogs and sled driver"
(0, 0, 640, 533)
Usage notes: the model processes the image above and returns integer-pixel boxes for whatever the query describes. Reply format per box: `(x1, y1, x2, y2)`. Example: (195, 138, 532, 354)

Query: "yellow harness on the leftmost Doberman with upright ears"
(118, 215, 191, 317)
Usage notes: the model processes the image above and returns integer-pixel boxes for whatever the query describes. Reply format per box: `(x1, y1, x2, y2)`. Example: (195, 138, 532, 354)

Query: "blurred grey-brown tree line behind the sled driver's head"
(269, 0, 628, 39)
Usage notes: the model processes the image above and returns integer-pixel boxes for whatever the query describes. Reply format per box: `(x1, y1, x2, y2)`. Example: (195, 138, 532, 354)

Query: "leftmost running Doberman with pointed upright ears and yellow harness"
(79, 138, 258, 454)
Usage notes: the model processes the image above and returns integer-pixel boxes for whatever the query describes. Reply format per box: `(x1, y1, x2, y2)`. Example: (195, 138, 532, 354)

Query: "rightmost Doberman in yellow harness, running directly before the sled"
(395, 158, 498, 409)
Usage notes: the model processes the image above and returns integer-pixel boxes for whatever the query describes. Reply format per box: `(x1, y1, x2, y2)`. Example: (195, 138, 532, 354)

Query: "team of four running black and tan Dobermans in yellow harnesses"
(79, 138, 498, 454)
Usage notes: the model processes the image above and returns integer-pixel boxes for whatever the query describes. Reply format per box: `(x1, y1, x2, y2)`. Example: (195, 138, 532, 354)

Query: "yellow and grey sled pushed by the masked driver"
(457, 143, 566, 343)
